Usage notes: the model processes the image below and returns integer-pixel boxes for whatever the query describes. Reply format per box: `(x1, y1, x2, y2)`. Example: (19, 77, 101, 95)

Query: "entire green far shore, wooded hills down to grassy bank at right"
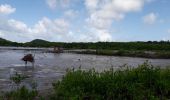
(0, 38, 170, 59)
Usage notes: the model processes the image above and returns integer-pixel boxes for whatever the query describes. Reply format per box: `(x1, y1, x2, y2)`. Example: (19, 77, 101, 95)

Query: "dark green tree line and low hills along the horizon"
(0, 38, 170, 51)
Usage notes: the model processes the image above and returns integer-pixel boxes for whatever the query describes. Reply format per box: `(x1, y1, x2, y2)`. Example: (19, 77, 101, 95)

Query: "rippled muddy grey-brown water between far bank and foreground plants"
(0, 50, 170, 91)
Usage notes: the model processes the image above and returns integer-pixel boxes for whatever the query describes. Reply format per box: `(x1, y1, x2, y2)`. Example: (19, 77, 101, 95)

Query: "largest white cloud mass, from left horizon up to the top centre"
(0, 0, 158, 42)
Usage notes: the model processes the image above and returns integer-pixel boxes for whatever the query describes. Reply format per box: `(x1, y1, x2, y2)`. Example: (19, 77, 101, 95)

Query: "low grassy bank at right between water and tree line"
(70, 50, 170, 59)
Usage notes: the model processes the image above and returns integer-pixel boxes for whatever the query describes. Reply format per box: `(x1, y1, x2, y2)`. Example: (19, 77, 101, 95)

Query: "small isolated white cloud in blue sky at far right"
(143, 13, 157, 24)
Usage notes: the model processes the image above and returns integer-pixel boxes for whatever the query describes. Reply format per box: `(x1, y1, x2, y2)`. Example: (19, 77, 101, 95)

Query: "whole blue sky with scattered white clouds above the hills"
(0, 0, 170, 42)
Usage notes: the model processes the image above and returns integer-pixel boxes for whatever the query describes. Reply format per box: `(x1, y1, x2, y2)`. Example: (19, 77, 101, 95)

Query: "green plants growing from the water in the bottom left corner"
(0, 73, 38, 100)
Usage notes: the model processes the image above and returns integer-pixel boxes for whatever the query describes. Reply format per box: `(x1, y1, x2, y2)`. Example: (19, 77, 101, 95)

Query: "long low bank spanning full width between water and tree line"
(0, 47, 170, 59)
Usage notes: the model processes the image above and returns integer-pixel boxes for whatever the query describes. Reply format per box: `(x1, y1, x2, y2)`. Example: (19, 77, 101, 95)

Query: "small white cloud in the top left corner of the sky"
(0, 4, 16, 15)
